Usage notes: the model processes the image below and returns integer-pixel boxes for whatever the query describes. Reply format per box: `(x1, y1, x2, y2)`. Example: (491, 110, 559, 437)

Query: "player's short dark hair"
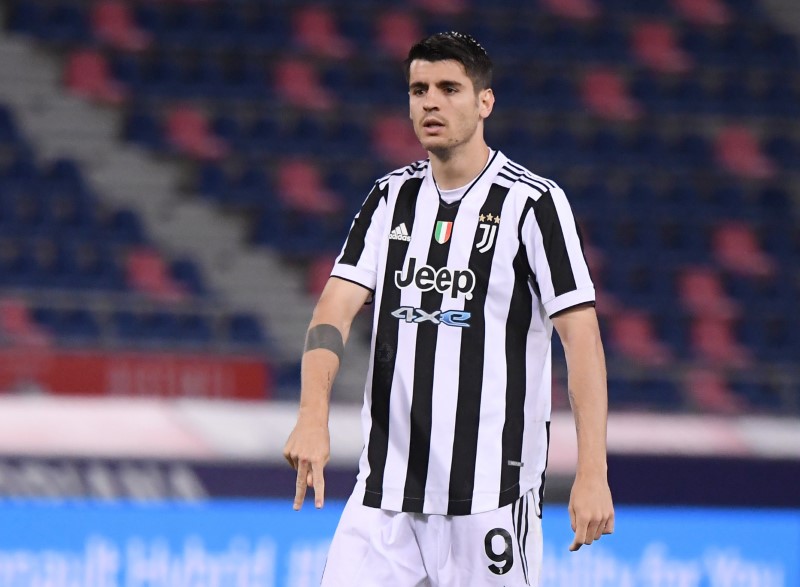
(403, 31, 492, 91)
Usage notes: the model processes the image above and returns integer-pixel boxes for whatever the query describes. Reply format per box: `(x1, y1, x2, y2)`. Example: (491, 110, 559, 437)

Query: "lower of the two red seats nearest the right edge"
(712, 221, 775, 277)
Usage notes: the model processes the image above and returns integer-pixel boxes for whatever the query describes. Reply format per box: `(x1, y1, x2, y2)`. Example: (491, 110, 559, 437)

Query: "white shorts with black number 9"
(322, 492, 542, 587)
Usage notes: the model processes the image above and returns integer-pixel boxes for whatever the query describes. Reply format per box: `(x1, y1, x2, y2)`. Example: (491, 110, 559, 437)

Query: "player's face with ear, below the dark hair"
(408, 59, 494, 156)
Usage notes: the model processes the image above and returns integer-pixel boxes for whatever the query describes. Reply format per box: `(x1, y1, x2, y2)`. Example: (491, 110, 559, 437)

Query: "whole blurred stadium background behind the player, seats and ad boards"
(0, 0, 800, 587)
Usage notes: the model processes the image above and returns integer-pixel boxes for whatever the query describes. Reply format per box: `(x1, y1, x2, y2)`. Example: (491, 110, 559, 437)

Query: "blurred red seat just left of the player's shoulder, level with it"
(277, 160, 342, 214)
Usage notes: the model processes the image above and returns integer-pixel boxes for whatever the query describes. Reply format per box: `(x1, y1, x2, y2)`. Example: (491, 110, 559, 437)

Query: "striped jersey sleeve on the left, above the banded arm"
(331, 184, 388, 291)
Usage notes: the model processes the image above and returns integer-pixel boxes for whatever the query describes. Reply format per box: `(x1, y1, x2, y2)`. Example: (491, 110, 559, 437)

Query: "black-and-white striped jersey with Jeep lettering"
(332, 152, 595, 515)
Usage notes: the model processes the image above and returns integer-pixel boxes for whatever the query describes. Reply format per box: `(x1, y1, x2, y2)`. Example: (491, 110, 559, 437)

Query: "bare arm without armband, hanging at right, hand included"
(553, 306, 614, 551)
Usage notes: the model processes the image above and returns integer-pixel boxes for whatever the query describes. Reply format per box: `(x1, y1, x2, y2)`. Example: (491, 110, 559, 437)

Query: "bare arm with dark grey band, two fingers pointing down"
(283, 277, 370, 510)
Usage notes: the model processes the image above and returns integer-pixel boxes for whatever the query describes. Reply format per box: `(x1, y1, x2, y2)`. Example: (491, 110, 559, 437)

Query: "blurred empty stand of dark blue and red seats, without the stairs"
(6, 0, 800, 414)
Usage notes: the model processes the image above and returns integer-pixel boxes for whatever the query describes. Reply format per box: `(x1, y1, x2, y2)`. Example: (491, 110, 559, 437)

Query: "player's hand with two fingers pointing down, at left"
(283, 415, 330, 510)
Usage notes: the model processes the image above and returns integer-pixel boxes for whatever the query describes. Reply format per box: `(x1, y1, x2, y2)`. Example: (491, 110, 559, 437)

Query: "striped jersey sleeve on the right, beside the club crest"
(520, 188, 595, 316)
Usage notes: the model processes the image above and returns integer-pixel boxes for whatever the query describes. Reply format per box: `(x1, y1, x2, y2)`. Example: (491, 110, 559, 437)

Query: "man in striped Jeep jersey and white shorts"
(284, 32, 614, 587)
